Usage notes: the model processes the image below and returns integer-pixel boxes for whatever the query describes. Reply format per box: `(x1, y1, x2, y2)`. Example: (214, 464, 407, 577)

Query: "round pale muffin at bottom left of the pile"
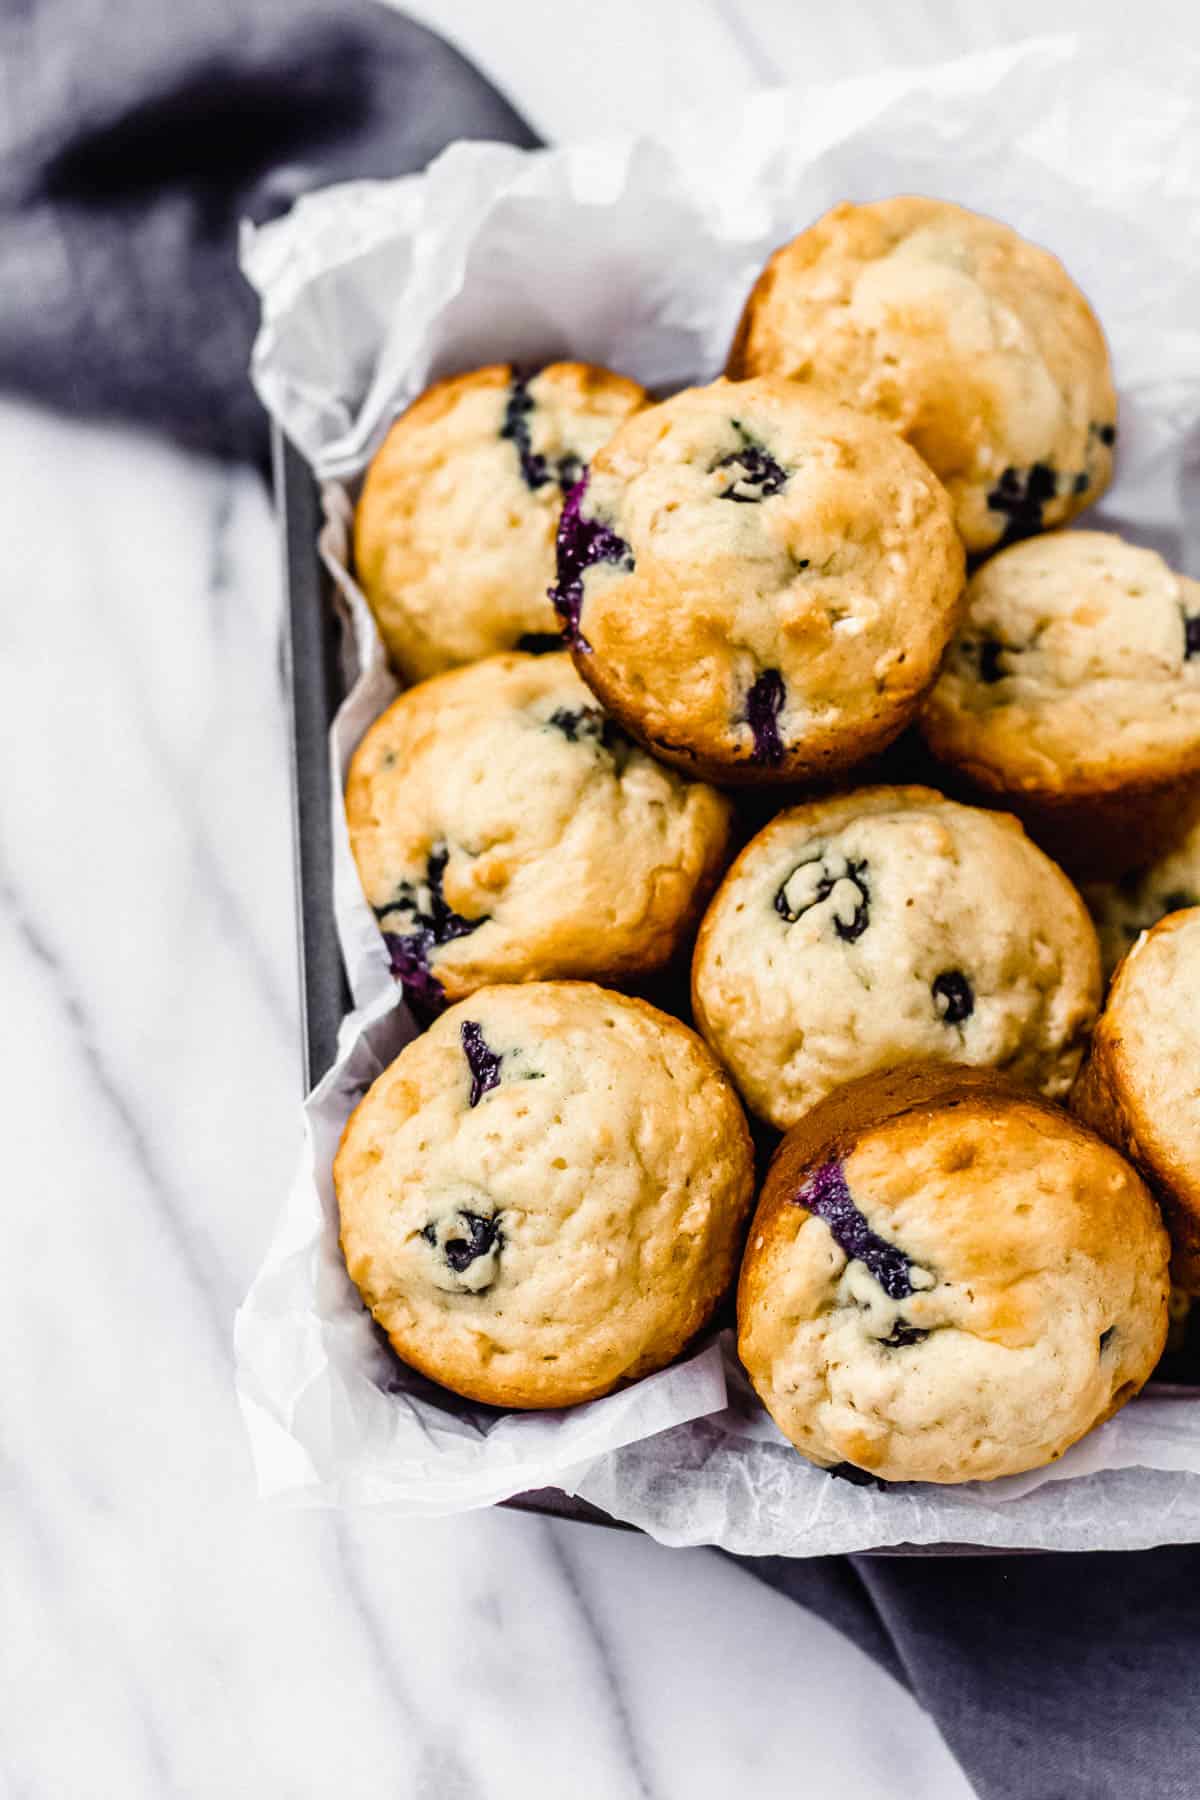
(333, 981, 754, 1406)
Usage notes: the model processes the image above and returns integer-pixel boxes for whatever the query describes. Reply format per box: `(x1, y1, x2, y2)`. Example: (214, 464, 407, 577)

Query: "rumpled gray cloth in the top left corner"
(0, 0, 536, 457)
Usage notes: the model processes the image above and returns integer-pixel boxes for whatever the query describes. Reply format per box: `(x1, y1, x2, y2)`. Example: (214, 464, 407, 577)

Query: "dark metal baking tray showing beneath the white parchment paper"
(272, 423, 1200, 1555)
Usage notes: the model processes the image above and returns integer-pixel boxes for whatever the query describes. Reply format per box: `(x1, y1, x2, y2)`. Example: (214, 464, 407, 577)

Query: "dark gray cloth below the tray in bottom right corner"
(741, 1548, 1200, 1800)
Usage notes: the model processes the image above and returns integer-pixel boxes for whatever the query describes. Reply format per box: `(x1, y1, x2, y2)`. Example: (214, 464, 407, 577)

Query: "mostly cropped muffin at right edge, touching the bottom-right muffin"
(1070, 907, 1200, 1294)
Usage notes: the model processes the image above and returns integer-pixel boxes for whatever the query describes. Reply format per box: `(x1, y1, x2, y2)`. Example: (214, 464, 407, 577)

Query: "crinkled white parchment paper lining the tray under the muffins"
(237, 38, 1200, 1555)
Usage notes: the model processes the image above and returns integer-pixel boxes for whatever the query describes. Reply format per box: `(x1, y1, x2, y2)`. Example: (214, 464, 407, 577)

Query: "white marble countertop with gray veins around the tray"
(11, 0, 1137, 1800)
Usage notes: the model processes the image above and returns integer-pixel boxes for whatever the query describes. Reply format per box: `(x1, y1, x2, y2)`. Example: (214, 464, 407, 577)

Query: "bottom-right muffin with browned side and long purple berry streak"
(738, 1067, 1168, 1481)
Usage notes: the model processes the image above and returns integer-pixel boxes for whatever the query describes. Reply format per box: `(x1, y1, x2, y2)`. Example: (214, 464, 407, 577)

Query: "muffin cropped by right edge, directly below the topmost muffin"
(921, 531, 1200, 878)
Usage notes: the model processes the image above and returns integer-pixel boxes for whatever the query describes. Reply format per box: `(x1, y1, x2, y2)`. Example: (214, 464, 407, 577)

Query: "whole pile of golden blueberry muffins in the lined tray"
(335, 198, 1200, 1481)
